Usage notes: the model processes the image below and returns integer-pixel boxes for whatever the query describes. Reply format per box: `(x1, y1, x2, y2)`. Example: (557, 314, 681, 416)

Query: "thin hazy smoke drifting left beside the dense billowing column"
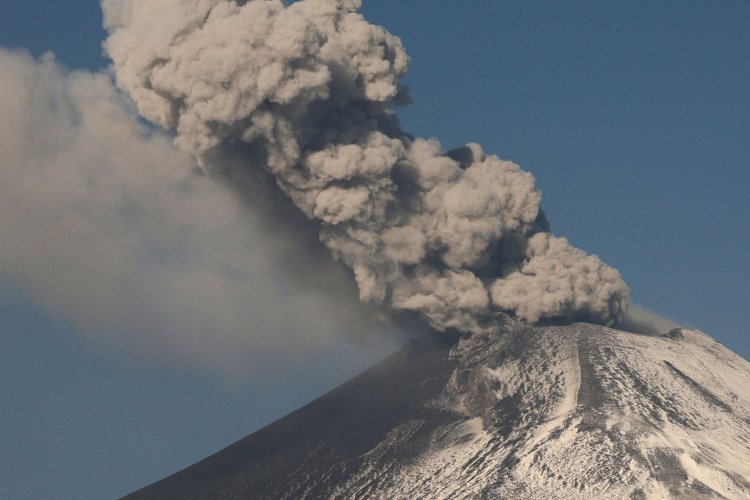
(0, 49, 395, 385)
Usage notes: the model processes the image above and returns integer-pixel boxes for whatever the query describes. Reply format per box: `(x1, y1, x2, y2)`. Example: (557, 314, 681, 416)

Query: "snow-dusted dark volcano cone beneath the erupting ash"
(126, 321, 750, 499)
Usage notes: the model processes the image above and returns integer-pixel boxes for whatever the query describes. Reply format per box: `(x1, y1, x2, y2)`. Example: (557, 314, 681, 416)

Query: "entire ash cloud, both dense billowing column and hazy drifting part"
(0, 0, 629, 380)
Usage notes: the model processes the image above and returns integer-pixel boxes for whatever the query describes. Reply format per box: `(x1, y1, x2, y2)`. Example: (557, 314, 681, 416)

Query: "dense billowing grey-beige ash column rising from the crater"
(102, 0, 630, 330)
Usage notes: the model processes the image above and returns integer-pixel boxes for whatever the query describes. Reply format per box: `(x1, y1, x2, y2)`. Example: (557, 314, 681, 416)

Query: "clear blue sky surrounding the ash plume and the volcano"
(0, 0, 750, 499)
